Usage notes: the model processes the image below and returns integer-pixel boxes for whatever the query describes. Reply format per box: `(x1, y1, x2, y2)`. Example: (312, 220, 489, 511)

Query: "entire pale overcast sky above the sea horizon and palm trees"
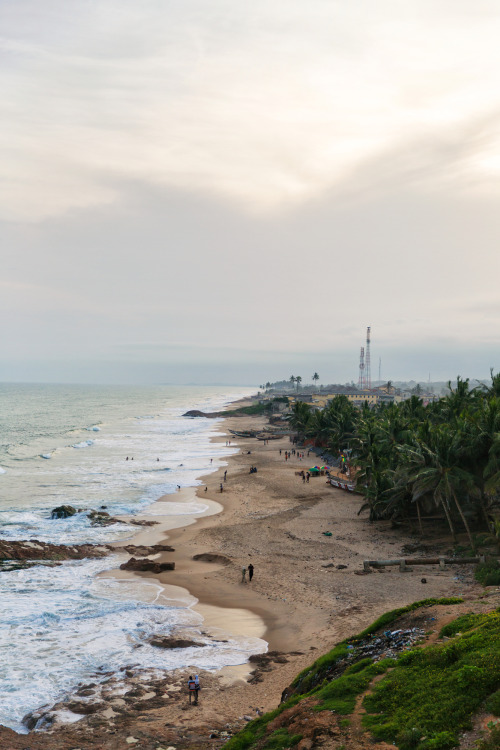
(0, 0, 500, 384)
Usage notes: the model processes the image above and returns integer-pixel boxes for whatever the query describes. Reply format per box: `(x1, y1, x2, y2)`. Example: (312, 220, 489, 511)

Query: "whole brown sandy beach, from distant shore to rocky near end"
(0, 400, 477, 750)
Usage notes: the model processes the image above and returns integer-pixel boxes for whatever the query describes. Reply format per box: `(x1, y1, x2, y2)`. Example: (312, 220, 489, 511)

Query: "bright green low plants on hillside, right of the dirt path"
(363, 610, 500, 750)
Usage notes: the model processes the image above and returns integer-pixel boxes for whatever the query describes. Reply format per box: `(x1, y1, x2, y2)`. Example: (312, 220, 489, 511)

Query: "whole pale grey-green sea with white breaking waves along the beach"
(0, 384, 265, 731)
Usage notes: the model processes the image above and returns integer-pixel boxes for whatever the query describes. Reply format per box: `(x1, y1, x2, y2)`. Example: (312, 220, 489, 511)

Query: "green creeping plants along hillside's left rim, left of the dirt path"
(224, 598, 463, 750)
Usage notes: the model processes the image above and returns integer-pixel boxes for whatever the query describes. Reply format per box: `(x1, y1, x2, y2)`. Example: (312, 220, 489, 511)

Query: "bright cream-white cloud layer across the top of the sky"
(0, 0, 500, 220)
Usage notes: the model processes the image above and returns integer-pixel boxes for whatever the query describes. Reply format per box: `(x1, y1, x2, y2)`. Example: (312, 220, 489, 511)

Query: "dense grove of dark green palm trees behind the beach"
(290, 373, 500, 549)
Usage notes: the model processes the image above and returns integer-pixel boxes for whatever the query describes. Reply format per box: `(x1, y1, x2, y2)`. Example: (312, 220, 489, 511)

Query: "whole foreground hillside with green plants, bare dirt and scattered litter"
(225, 599, 500, 750)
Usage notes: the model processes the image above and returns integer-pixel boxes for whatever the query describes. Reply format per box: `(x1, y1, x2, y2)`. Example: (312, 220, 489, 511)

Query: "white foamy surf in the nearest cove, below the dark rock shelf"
(0, 558, 265, 731)
